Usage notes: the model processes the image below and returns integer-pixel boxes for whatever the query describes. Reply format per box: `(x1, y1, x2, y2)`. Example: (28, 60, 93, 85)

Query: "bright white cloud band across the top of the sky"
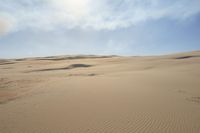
(0, 0, 200, 33)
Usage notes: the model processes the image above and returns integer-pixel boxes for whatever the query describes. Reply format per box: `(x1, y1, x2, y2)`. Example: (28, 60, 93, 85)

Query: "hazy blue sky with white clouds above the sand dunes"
(0, 0, 200, 58)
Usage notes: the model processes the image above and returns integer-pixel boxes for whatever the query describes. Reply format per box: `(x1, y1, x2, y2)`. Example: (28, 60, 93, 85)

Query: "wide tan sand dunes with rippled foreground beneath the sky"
(0, 51, 200, 133)
